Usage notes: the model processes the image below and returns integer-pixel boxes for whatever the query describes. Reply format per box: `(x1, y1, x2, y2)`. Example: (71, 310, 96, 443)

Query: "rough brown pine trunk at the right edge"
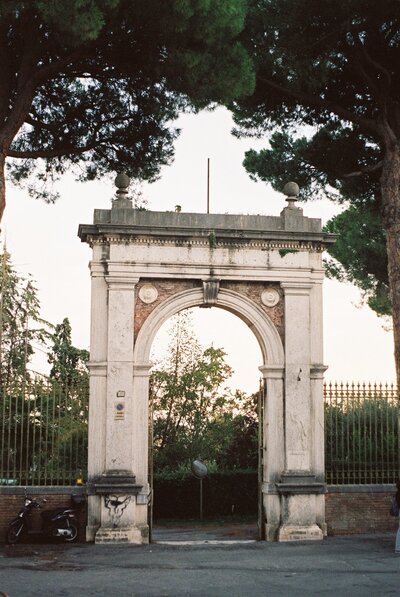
(381, 143, 400, 387)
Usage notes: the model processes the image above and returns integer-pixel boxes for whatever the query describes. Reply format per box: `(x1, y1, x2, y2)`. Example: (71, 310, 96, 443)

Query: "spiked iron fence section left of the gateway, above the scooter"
(0, 374, 89, 485)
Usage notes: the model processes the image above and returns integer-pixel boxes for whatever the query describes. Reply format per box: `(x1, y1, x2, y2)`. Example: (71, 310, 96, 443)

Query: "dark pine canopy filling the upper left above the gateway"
(0, 0, 254, 219)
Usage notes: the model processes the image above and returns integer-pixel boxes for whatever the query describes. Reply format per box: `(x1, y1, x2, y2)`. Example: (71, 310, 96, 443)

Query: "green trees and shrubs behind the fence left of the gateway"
(0, 252, 89, 484)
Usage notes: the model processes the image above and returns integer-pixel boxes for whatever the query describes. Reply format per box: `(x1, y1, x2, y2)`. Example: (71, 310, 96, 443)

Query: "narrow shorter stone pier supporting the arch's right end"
(259, 365, 285, 541)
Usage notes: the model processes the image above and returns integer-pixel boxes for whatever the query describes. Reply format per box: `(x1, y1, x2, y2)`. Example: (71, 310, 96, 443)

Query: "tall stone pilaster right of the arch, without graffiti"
(276, 281, 324, 541)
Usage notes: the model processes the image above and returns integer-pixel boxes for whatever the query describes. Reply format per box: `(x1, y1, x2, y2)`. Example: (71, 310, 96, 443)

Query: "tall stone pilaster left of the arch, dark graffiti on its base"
(90, 271, 142, 543)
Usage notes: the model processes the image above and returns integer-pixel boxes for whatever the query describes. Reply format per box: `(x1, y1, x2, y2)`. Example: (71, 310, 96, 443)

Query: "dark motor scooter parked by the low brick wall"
(6, 494, 84, 545)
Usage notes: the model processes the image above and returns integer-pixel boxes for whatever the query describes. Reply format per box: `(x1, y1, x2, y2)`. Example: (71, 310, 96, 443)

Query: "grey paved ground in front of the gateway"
(0, 535, 400, 597)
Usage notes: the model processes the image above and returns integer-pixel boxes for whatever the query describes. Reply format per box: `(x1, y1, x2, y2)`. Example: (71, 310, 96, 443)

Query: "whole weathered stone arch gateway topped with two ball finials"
(79, 176, 333, 543)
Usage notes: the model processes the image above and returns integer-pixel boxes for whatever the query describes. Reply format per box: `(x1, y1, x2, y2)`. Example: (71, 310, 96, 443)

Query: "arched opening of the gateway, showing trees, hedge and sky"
(149, 308, 262, 542)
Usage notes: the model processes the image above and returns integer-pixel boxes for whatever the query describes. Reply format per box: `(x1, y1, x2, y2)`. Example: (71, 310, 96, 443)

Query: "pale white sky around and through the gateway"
(1, 108, 395, 392)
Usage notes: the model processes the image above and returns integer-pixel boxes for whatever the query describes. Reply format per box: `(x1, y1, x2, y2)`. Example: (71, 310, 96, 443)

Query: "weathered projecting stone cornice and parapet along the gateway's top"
(78, 209, 336, 251)
